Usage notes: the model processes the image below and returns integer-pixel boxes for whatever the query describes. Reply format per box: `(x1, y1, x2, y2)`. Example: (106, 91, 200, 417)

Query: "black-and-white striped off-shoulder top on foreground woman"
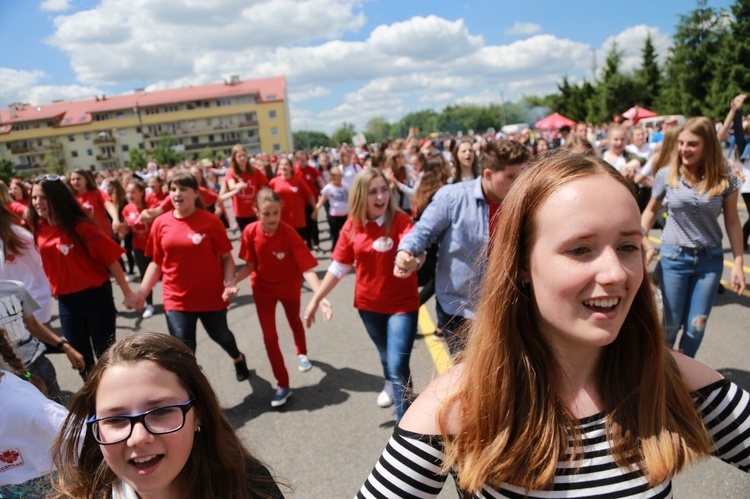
(357, 379, 750, 499)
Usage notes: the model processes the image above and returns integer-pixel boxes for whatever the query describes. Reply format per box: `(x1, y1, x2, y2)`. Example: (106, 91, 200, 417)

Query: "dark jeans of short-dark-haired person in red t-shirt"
(164, 309, 242, 359)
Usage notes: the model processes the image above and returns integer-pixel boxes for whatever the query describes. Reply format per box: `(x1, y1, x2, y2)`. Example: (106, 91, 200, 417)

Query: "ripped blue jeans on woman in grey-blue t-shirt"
(659, 244, 724, 357)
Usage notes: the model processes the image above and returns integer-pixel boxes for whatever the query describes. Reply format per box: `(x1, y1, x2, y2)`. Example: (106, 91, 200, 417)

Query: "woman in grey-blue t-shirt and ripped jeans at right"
(641, 117, 745, 357)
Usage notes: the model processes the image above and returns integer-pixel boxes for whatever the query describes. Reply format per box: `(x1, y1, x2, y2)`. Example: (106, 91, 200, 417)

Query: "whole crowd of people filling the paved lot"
(0, 95, 750, 498)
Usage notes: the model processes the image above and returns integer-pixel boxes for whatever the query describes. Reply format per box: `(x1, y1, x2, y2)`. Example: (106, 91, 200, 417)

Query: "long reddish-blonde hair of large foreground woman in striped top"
(437, 151, 710, 493)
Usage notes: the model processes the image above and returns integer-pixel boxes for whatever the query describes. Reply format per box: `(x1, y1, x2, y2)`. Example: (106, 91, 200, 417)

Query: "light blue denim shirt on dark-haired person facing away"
(398, 177, 490, 319)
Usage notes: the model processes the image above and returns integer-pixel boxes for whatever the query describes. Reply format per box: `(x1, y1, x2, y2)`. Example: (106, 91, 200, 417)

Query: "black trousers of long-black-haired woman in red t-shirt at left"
(58, 280, 117, 379)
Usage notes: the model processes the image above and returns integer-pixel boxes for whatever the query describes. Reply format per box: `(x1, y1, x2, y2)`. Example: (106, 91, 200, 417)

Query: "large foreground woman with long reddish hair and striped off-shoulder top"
(358, 151, 750, 498)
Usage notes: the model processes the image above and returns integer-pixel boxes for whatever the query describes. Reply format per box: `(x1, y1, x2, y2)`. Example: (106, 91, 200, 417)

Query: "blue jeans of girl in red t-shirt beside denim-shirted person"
(359, 310, 418, 422)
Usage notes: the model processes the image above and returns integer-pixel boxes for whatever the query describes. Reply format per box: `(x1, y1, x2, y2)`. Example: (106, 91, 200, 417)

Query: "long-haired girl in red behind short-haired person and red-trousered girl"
(224, 144, 268, 232)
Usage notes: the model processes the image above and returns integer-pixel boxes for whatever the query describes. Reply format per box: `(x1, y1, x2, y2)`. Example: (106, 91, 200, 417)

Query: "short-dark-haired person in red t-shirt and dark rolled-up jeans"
(138, 171, 250, 381)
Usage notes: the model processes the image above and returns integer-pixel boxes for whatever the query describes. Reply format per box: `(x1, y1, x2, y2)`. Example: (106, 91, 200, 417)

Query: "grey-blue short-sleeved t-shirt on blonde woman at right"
(651, 167, 741, 248)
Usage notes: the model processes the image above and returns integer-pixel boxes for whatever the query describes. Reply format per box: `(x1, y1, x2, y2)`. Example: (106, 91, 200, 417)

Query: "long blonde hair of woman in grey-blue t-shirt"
(667, 116, 730, 198)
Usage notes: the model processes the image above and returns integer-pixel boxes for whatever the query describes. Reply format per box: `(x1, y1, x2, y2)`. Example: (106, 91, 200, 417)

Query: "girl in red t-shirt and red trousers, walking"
(225, 189, 331, 407)
